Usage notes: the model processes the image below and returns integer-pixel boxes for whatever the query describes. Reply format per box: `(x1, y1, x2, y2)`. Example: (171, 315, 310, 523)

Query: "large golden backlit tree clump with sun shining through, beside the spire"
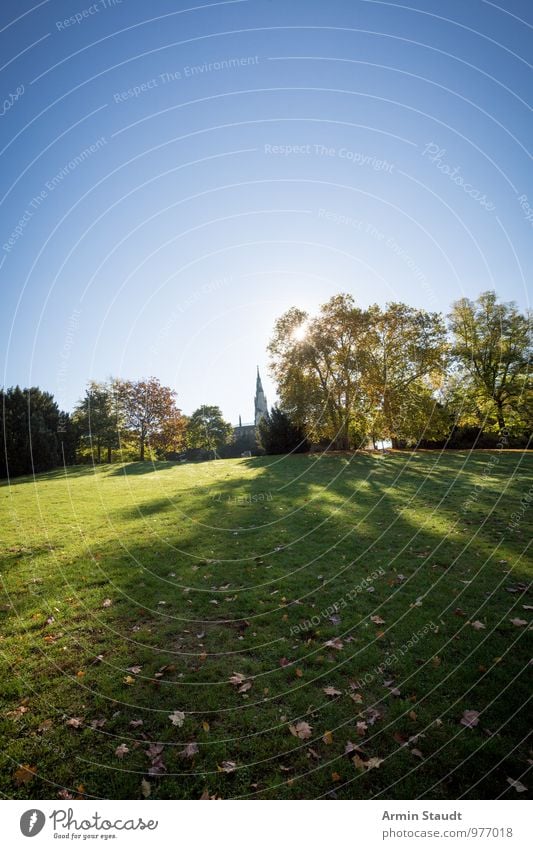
(269, 294, 446, 449)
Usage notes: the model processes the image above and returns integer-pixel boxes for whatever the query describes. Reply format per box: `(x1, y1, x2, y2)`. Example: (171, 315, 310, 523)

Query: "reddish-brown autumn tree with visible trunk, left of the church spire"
(113, 377, 179, 461)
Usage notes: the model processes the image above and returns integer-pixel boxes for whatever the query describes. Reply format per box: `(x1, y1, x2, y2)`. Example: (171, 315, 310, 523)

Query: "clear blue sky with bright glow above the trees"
(0, 0, 533, 422)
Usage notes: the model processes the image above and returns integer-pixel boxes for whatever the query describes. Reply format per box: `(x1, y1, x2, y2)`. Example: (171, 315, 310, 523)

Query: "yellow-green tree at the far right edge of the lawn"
(449, 291, 532, 432)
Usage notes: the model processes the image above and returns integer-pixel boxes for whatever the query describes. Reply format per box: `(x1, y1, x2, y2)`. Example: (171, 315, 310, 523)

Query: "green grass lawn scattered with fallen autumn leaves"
(0, 451, 533, 799)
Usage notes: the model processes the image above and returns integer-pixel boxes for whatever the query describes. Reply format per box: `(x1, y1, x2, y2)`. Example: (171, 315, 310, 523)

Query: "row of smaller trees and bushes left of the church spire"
(0, 377, 233, 478)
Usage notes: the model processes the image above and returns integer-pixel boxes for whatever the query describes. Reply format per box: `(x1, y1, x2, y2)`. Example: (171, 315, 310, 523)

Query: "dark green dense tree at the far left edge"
(0, 386, 68, 477)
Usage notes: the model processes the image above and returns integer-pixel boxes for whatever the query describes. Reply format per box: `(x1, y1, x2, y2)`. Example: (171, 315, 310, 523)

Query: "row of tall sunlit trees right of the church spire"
(269, 292, 533, 449)
